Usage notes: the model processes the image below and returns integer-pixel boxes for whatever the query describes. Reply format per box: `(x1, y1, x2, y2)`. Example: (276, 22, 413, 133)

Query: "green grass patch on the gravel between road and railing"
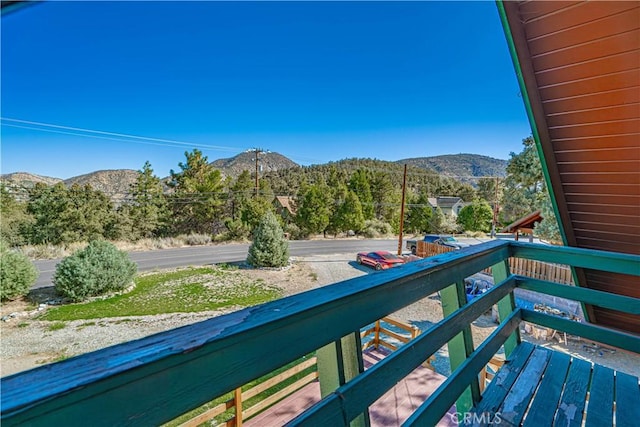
(41, 267, 282, 320)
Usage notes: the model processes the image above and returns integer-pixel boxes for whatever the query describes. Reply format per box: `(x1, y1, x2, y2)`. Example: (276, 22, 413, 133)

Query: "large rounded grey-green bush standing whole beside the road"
(53, 240, 136, 301)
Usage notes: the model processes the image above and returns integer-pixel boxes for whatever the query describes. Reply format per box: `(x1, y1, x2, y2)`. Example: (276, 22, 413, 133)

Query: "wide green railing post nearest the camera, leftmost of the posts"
(316, 332, 370, 427)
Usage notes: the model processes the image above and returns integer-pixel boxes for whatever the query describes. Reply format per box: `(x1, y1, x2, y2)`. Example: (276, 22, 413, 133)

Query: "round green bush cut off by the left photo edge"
(0, 243, 38, 301)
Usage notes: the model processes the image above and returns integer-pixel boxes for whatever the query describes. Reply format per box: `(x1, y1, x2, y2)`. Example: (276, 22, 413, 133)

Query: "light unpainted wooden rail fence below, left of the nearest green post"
(180, 356, 318, 427)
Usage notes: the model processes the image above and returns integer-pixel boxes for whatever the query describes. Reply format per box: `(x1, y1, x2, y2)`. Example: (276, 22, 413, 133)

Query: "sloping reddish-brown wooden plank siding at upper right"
(502, 1, 640, 333)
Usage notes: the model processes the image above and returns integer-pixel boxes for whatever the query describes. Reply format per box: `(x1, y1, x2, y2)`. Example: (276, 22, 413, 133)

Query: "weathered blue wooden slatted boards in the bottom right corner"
(471, 343, 640, 427)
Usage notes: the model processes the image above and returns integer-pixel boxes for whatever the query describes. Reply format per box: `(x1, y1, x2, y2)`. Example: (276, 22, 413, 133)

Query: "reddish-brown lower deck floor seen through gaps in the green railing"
(244, 348, 456, 427)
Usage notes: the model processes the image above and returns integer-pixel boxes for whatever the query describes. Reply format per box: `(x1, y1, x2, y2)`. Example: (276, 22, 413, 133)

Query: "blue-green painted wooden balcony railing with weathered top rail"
(0, 241, 640, 426)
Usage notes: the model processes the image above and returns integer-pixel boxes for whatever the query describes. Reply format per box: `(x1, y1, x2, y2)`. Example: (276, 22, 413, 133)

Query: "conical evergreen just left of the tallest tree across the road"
(128, 161, 168, 238)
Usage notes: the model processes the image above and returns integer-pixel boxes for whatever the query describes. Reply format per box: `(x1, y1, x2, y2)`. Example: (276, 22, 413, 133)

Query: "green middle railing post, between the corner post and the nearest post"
(440, 280, 480, 413)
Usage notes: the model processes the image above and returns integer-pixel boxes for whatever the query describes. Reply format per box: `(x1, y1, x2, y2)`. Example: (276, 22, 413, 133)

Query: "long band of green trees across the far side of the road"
(0, 138, 553, 246)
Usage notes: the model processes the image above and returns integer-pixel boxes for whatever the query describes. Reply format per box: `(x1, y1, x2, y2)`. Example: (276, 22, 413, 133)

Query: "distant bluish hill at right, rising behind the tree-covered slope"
(396, 154, 509, 182)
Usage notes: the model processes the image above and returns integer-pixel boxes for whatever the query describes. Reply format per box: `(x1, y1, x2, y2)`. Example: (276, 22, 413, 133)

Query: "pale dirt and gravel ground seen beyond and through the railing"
(0, 254, 640, 376)
